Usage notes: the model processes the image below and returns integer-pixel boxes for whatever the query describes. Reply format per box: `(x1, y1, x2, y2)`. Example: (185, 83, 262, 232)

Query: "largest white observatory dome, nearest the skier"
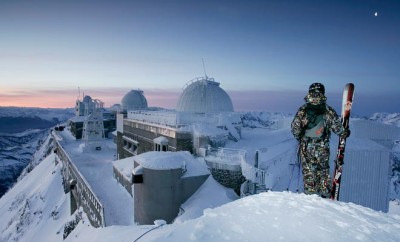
(176, 77, 233, 113)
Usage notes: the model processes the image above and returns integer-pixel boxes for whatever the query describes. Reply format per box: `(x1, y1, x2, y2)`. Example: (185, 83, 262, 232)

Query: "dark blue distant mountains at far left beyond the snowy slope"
(0, 107, 74, 197)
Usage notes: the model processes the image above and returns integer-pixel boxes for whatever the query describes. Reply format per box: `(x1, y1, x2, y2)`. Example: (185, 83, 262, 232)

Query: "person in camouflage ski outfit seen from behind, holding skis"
(291, 83, 350, 198)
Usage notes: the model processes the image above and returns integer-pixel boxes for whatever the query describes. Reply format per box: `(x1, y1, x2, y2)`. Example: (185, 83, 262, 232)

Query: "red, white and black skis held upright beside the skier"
(331, 83, 354, 200)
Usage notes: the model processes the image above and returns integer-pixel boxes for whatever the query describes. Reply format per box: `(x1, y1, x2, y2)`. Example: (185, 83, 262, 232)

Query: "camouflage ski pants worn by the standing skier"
(300, 139, 331, 197)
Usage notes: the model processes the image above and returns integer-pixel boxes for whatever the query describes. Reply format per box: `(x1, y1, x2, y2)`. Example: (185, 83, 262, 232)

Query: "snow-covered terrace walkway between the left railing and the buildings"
(57, 129, 133, 226)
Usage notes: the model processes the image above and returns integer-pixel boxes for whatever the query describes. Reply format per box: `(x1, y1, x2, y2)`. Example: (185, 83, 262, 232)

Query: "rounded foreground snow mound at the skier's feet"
(66, 192, 400, 242)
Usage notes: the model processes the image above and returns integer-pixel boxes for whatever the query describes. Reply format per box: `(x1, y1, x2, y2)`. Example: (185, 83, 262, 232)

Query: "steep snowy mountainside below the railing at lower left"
(0, 154, 70, 241)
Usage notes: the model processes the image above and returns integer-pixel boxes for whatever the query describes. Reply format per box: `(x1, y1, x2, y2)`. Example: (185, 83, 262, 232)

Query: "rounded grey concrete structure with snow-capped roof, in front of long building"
(114, 151, 209, 224)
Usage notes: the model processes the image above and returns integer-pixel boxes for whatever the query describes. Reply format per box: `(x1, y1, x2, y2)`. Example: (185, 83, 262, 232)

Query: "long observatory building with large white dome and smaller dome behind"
(117, 77, 241, 159)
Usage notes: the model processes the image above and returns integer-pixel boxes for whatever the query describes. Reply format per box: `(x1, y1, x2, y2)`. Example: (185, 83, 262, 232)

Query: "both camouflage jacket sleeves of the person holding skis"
(291, 103, 344, 141)
